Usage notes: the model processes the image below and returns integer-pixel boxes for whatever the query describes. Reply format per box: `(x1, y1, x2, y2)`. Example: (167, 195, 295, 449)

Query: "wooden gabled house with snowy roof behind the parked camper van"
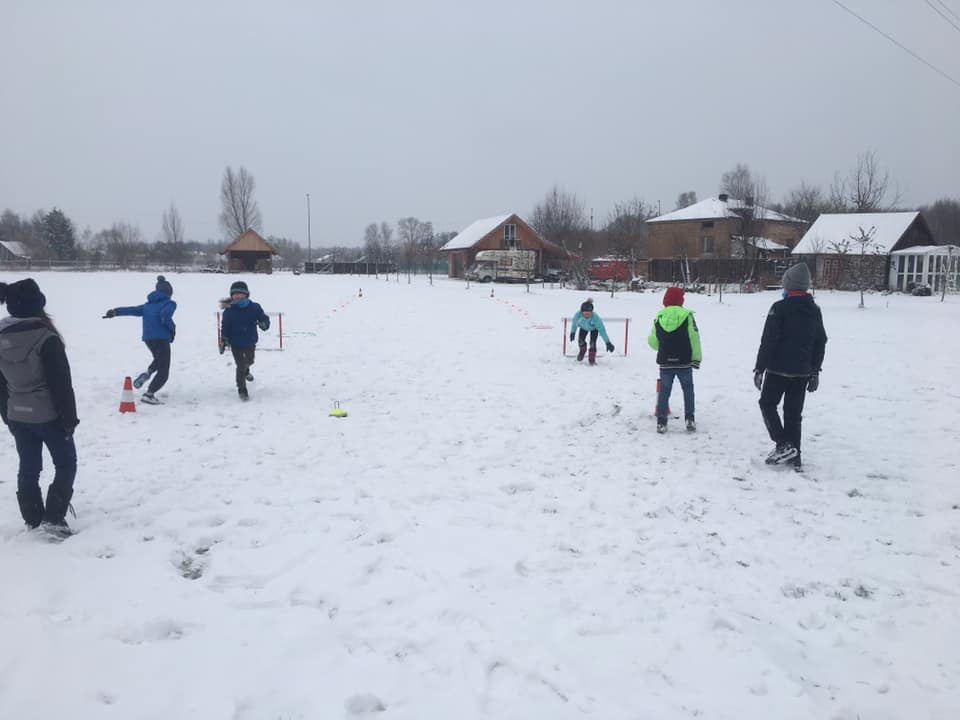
(440, 213, 568, 278)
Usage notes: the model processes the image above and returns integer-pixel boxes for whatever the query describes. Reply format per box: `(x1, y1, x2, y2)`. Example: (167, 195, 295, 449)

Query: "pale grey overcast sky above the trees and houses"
(0, 0, 960, 246)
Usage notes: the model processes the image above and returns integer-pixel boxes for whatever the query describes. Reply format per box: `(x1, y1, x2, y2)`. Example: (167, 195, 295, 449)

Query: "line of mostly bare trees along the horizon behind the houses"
(0, 151, 960, 272)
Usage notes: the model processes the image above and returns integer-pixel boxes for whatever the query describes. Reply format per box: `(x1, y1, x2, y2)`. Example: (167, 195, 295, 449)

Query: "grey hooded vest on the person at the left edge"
(0, 317, 57, 423)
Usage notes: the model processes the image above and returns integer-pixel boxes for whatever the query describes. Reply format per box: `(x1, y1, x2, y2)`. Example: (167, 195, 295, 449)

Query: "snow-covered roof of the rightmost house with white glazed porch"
(792, 212, 920, 255)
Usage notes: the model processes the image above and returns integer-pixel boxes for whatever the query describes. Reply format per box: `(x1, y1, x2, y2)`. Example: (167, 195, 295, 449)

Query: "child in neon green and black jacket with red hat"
(647, 287, 701, 433)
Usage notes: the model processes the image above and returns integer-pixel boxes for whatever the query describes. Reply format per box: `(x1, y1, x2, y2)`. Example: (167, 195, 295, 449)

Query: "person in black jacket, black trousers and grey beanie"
(753, 263, 827, 470)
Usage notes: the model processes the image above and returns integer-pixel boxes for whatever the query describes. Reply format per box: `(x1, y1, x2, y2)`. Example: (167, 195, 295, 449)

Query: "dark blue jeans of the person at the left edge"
(10, 420, 77, 502)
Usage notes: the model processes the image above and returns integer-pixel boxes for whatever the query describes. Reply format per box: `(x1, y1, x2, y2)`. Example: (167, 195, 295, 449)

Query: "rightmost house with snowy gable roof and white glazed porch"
(791, 212, 940, 290)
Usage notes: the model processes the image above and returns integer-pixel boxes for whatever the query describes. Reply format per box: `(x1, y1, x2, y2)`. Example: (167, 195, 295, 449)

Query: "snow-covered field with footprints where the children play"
(0, 273, 960, 720)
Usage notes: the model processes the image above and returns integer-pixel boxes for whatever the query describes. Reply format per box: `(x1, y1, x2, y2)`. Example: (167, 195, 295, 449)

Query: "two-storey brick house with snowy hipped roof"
(647, 194, 806, 282)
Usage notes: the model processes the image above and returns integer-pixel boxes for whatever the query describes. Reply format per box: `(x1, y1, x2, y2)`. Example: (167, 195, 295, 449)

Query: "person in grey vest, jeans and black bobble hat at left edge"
(0, 278, 80, 537)
